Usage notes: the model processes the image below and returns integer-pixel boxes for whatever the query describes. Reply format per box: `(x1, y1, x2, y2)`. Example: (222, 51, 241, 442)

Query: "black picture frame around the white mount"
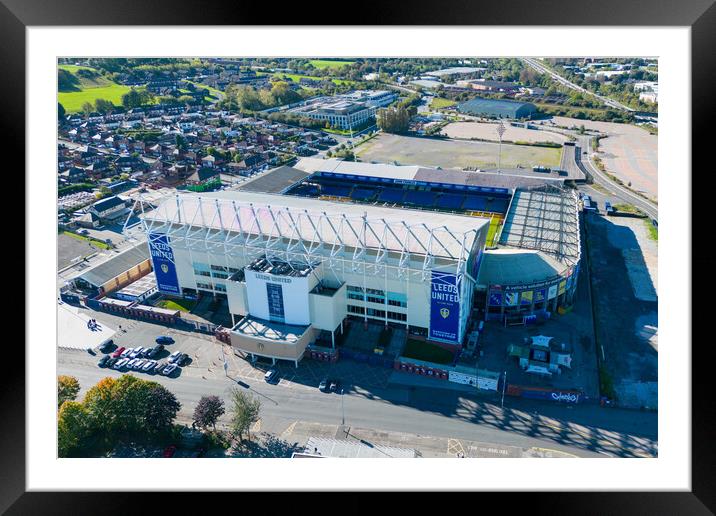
(8, 0, 716, 514)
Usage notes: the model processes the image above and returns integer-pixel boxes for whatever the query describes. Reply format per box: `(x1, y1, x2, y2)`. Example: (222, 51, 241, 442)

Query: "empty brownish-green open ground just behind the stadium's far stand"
(356, 134, 562, 169)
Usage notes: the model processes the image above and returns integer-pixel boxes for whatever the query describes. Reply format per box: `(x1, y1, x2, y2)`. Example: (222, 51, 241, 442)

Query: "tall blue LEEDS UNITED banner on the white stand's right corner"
(430, 271, 462, 343)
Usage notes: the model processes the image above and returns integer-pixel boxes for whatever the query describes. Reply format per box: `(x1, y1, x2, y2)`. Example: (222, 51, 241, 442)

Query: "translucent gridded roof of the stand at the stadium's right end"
(500, 187, 580, 265)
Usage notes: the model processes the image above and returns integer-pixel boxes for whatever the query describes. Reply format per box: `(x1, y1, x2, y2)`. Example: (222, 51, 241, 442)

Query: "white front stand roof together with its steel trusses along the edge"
(141, 195, 480, 281)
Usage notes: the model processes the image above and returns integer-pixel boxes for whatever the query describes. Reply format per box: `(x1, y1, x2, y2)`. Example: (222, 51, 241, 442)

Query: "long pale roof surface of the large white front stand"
(142, 190, 489, 264)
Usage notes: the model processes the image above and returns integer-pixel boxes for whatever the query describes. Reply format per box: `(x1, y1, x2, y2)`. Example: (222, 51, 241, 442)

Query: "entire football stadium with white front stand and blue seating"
(141, 158, 580, 364)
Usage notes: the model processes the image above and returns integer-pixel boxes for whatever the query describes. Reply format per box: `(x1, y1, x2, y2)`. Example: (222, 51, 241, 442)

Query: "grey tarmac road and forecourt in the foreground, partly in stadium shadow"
(57, 304, 657, 457)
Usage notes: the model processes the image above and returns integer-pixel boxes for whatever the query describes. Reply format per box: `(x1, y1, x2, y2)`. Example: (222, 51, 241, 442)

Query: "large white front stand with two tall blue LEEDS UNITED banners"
(142, 191, 489, 364)
